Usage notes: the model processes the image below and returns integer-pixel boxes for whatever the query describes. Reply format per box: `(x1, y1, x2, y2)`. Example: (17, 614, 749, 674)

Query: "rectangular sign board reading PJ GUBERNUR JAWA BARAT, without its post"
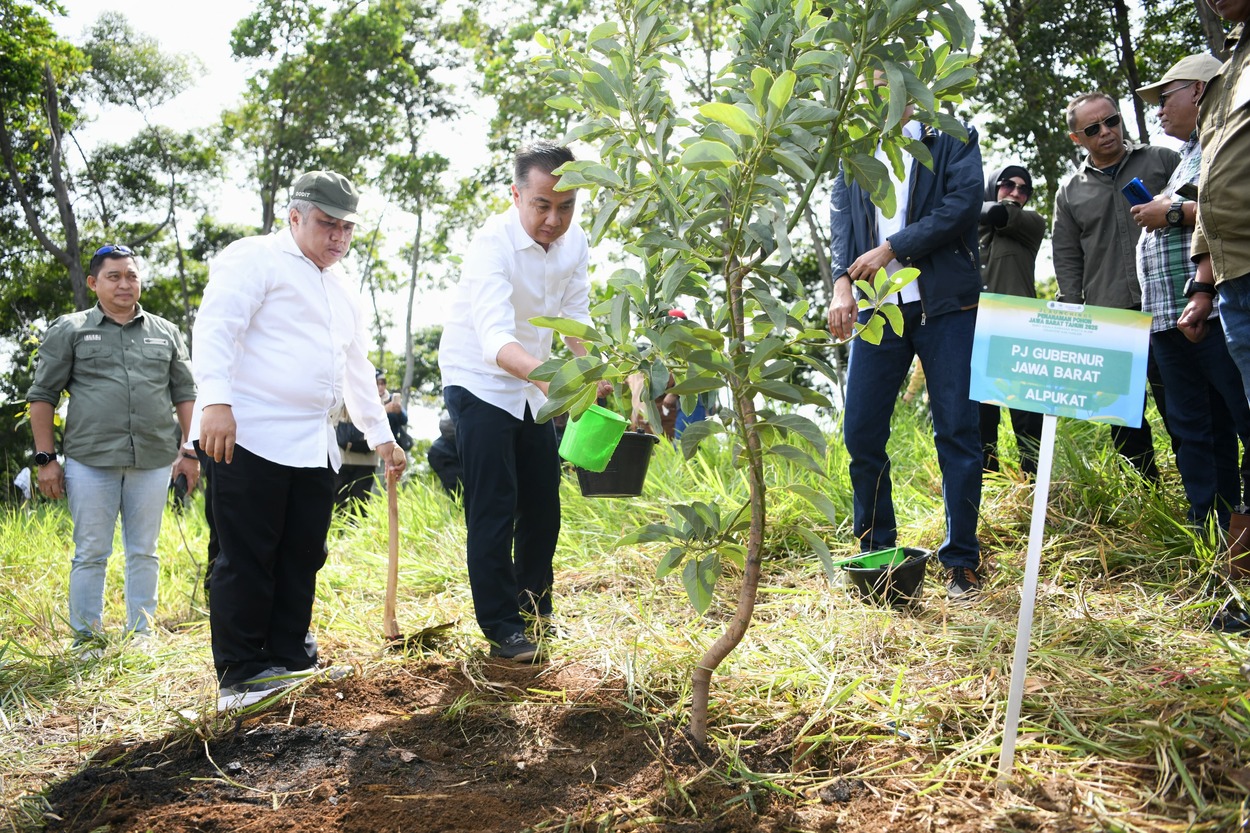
(969, 293, 1150, 428)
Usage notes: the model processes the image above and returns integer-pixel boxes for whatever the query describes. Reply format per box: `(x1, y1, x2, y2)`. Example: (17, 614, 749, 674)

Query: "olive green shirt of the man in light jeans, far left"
(26, 305, 195, 469)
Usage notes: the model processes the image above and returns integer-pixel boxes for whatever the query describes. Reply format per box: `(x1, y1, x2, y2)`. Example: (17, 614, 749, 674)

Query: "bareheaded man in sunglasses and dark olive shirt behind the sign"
(1051, 93, 1180, 483)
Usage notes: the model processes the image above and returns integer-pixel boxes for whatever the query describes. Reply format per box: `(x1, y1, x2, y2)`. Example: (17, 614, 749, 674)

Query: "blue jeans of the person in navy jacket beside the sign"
(843, 301, 981, 569)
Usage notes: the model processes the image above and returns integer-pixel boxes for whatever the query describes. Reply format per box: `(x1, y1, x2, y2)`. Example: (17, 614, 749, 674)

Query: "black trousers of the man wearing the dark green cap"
(209, 445, 334, 685)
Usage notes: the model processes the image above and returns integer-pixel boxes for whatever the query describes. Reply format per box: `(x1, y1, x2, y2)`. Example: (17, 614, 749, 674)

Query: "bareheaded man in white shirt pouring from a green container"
(439, 141, 605, 662)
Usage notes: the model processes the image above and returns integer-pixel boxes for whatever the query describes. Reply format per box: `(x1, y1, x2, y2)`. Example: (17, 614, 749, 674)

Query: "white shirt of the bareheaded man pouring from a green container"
(439, 205, 590, 419)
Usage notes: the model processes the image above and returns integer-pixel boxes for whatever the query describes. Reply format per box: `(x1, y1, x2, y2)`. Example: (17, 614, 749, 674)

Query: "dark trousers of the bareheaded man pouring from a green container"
(443, 385, 560, 643)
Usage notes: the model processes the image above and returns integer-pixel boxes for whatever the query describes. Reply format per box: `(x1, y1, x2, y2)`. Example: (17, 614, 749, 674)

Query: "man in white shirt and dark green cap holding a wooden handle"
(193, 171, 404, 709)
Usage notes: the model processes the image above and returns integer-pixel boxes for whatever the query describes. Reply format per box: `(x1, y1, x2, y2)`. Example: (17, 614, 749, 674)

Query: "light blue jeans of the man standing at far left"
(65, 458, 169, 637)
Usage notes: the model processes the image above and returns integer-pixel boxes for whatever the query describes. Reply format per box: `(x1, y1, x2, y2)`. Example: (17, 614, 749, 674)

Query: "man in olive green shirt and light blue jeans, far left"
(26, 245, 200, 650)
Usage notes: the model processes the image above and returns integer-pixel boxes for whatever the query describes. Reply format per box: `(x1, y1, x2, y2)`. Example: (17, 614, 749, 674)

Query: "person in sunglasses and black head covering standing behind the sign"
(979, 165, 1046, 474)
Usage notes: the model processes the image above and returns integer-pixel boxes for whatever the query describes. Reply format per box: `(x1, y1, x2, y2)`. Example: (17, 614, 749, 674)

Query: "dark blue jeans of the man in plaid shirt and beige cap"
(1150, 318, 1250, 529)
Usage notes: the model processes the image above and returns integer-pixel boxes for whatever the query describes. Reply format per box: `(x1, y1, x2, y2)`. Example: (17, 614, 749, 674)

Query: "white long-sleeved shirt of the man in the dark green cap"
(191, 229, 394, 470)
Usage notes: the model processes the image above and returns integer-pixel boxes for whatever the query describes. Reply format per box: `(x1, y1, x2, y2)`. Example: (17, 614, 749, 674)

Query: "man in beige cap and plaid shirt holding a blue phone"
(1133, 53, 1250, 529)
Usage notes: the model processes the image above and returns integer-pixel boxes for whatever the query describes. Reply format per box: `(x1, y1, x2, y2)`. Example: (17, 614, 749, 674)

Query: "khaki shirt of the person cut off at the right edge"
(1190, 24, 1250, 284)
